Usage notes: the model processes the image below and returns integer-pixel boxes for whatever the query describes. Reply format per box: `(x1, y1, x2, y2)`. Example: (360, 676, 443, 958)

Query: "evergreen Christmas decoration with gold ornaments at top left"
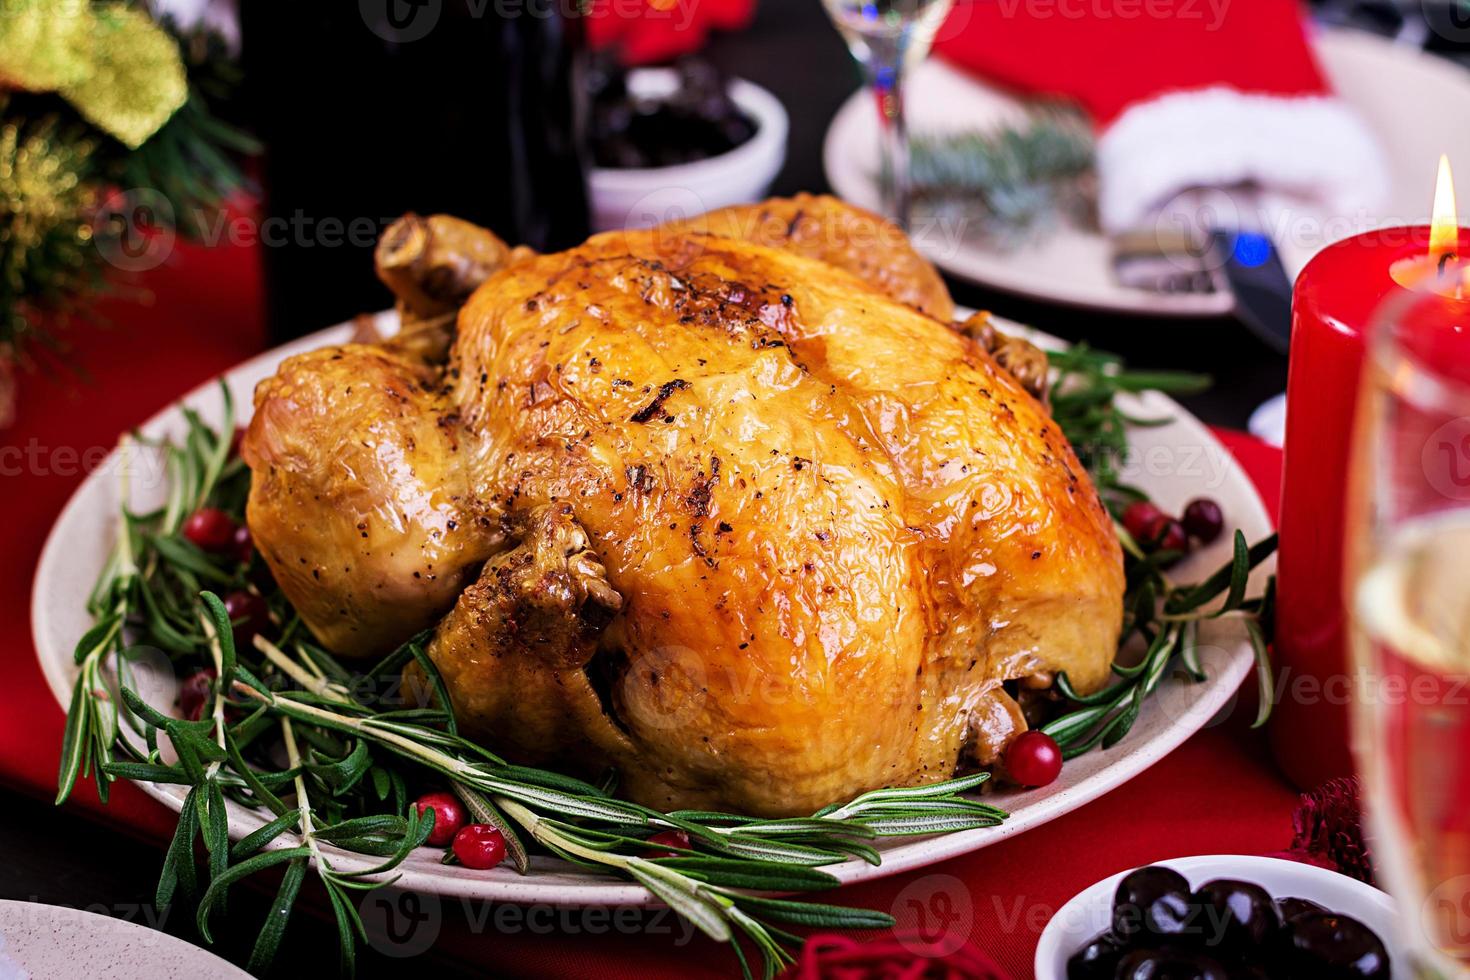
(0, 0, 256, 429)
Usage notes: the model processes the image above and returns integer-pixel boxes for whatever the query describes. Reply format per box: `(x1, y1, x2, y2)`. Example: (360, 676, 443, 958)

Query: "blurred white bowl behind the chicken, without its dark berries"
(588, 68, 789, 231)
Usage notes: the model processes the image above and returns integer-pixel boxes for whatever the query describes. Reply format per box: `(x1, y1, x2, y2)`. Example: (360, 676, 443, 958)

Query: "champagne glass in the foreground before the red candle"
(1347, 279, 1470, 979)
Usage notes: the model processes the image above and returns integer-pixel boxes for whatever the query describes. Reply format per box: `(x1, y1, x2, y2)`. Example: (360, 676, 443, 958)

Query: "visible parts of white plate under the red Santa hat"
(823, 29, 1470, 317)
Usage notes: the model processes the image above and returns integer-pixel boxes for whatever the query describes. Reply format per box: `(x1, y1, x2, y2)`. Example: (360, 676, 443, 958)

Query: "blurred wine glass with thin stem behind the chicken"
(822, 0, 954, 229)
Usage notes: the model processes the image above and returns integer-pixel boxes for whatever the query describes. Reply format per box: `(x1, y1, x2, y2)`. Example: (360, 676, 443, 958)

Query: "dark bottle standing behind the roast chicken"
(241, 0, 588, 341)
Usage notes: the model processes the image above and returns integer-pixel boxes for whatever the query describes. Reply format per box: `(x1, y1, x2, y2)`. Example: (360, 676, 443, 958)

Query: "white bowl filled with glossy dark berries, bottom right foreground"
(1036, 854, 1404, 980)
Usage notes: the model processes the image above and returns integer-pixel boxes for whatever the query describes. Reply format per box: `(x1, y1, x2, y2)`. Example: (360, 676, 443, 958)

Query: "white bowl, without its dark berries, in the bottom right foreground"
(1036, 854, 1407, 980)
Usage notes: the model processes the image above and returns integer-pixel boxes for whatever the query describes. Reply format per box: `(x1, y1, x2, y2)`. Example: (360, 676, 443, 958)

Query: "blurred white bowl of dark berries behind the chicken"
(588, 59, 789, 231)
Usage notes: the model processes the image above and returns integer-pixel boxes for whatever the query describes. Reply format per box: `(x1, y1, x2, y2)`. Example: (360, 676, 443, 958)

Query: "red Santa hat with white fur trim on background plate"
(935, 0, 1388, 231)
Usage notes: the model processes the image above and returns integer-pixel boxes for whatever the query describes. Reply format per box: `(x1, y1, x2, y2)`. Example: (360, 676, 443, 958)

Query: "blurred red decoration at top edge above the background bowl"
(584, 0, 756, 65)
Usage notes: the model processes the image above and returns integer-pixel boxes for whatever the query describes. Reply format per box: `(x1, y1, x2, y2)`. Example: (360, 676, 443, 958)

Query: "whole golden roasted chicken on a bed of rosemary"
(243, 197, 1123, 815)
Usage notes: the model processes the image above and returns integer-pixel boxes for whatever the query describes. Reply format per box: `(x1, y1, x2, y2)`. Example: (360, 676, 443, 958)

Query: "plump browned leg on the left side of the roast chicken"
(241, 344, 504, 657)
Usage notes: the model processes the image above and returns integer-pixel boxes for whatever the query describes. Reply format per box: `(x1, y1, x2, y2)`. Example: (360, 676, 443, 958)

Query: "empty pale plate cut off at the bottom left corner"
(0, 901, 250, 980)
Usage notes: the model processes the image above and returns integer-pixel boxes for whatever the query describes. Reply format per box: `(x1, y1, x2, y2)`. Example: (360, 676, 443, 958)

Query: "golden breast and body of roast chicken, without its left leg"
(435, 231, 1123, 814)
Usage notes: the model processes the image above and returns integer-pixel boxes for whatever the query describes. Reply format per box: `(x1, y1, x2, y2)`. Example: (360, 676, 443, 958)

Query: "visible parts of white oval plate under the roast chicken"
(31, 312, 1274, 905)
